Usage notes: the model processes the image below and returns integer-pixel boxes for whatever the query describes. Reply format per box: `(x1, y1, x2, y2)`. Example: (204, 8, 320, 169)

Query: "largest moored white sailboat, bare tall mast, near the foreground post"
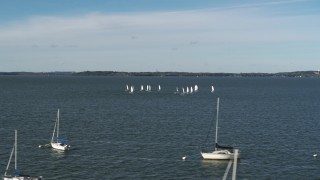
(200, 98, 240, 160)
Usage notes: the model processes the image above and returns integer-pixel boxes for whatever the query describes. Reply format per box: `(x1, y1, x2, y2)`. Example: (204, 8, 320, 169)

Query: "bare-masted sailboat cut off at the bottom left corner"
(3, 130, 42, 180)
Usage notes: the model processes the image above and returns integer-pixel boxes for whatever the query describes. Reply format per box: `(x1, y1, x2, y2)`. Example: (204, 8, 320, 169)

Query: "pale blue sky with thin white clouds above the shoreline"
(0, 0, 320, 73)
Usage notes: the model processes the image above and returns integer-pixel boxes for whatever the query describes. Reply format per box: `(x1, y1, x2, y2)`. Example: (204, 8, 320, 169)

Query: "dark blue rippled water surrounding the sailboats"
(0, 76, 320, 179)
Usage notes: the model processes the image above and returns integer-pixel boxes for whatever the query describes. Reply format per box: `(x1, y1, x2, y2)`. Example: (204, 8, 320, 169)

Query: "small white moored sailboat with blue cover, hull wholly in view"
(51, 109, 71, 151)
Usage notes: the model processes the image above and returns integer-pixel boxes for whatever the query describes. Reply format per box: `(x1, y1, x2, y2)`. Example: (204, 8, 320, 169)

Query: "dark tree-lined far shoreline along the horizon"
(0, 71, 320, 77)
